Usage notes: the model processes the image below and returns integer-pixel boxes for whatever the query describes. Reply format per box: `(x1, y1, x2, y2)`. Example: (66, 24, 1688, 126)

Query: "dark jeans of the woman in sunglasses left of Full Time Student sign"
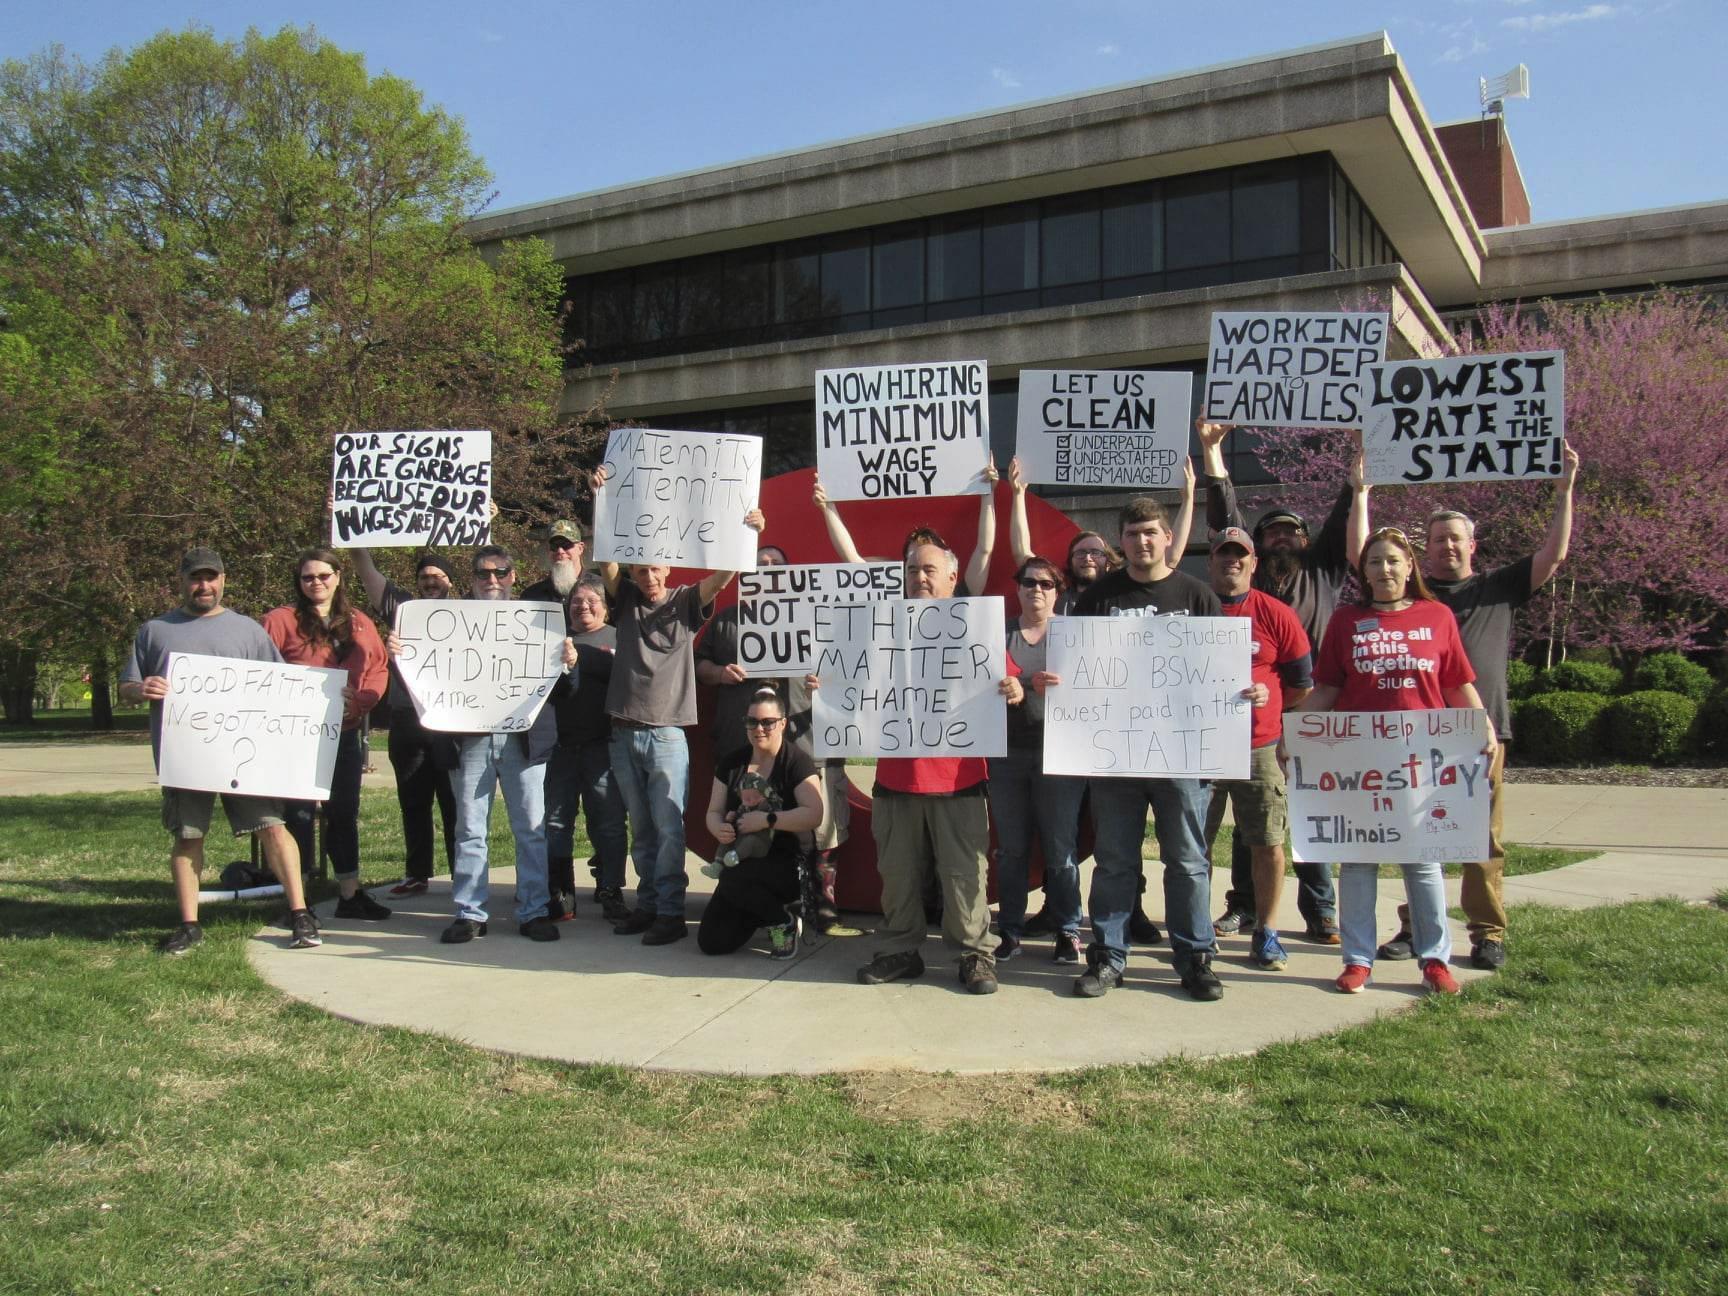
(990, 752, 1085, 937)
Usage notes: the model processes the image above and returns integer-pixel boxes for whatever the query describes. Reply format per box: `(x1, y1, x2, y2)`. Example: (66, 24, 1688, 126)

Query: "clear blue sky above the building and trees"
(0, 0, 1728, 219)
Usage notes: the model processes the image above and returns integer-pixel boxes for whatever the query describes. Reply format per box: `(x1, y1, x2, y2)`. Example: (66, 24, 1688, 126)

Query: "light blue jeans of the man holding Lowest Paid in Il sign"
(449, 733, 548, 923)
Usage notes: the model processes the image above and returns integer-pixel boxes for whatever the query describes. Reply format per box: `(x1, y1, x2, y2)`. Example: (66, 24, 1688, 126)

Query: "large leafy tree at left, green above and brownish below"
(0, 28, 593, 725)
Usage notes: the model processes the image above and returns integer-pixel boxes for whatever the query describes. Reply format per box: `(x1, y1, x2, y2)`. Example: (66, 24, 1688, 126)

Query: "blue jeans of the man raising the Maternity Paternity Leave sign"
(612, 724, 689, 918)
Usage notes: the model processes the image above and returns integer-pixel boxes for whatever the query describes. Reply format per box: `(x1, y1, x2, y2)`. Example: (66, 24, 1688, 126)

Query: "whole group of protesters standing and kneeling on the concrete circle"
(121, 422, 1578, 1001)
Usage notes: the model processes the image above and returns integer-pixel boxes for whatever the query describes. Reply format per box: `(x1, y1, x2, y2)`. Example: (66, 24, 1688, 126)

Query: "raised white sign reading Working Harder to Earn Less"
(1201, 311, 1388, 427)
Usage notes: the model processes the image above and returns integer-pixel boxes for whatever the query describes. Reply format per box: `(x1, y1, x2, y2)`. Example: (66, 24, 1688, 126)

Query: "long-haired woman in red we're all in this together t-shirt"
(1299, 527, 1498, 994)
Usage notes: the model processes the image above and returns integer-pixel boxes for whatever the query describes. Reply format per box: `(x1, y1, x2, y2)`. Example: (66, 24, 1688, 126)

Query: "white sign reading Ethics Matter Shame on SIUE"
(810, 598, 1007, 757)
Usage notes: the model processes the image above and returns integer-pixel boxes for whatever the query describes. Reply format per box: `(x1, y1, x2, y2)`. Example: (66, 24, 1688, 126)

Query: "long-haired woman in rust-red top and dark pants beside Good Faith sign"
(264, 548, 391, 923)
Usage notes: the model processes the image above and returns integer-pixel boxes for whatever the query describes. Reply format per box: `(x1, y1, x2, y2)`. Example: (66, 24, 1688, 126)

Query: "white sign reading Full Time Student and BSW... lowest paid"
(1044, 617, 1253, 779)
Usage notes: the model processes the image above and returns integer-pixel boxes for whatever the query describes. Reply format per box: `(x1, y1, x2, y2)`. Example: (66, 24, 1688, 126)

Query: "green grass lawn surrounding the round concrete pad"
(0, 793, 1728, 1296)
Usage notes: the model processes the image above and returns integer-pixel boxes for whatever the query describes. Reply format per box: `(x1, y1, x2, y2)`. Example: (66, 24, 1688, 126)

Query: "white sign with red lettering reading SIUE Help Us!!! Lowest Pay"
(1284, 708, 1490, 864)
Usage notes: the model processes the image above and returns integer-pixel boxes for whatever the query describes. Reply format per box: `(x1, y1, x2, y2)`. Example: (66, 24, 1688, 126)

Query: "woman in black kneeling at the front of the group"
(696, 688, 823, 959)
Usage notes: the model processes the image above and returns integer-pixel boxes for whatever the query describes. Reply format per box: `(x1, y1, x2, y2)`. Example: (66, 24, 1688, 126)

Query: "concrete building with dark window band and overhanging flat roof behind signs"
(472, 33, 1728, 515)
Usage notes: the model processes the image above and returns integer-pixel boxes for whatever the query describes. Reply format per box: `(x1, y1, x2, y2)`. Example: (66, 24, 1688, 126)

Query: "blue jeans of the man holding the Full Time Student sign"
(1087, 779, 1217, 973)
